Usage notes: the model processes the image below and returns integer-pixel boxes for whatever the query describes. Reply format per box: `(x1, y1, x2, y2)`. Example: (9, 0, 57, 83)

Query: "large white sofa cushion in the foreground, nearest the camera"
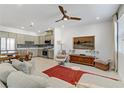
(7, 71, 48, 88)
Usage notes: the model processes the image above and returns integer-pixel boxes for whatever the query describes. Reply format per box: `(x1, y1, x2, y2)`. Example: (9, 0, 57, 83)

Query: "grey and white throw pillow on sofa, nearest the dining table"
(12, 60, 32, 74)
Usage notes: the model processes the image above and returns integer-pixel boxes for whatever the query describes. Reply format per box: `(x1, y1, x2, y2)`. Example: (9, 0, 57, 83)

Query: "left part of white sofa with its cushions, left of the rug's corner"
(0, 63, 75, 88)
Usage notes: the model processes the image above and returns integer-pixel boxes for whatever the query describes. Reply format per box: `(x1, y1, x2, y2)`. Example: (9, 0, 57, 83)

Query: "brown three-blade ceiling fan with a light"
(55, 6, 81, 22)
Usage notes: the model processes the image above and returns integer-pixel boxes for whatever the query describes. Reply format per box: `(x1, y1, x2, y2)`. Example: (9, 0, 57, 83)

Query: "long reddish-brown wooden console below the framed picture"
(69, 55, 95, 66)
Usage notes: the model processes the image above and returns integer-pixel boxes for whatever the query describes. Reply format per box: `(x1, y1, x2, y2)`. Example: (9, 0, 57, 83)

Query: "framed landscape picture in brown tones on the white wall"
(73, 36, 95, 50)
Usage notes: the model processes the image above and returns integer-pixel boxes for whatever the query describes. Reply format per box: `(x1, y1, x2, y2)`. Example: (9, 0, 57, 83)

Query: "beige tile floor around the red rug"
(31, 57, 120, 79)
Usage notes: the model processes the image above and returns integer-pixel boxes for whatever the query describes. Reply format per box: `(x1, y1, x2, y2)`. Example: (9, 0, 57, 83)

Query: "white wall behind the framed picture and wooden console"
(61, 22, 114, 61)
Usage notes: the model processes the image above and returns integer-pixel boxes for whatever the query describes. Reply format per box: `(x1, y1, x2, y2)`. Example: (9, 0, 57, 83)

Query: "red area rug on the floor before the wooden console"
(43, 65, 85, 85)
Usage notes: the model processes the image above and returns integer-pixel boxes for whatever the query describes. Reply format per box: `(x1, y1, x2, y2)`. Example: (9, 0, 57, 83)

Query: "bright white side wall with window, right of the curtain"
(118, 5, 124, 80)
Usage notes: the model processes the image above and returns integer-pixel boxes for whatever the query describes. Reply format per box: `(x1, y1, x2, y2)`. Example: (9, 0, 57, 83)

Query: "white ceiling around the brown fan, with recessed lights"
(0, 4, 119, 33)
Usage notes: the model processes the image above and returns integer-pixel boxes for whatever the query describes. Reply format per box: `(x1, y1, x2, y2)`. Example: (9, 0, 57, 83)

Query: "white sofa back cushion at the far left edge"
(0, 63, 17, 83)
